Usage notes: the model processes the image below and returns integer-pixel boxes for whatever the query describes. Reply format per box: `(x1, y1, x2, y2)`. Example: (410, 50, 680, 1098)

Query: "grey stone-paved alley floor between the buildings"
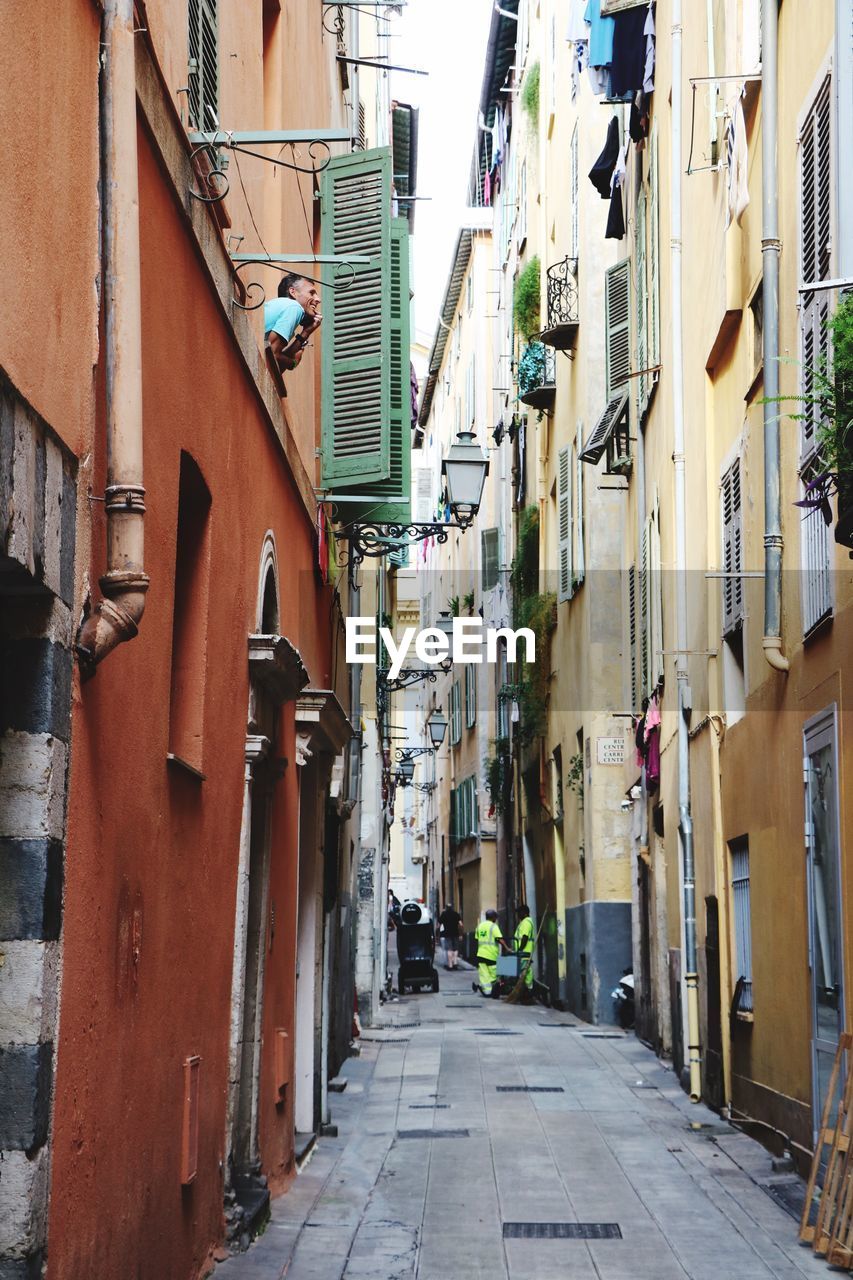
(216, 970, 827, 1280)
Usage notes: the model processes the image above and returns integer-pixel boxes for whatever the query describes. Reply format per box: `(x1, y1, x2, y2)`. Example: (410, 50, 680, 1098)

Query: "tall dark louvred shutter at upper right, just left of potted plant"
(800, 76, 833, 460)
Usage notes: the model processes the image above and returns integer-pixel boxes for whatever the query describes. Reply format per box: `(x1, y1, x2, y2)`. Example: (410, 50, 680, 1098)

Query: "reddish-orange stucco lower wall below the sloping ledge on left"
(49, 102, 330, 1280)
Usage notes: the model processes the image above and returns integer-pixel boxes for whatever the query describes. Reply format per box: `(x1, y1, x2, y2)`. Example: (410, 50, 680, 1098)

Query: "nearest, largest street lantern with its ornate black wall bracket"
(334, 431, 489, 564)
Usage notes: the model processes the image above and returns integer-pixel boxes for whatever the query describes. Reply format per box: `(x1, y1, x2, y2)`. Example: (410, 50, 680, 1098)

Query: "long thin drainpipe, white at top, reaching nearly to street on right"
(671, 0, 696, 1102)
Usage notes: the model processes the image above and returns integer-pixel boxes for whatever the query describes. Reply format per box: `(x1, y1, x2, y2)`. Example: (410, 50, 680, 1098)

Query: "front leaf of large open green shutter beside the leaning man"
(320, 147, 392, 492)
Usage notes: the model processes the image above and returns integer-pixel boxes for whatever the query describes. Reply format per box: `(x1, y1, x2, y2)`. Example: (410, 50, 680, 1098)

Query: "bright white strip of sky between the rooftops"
(389, 0, 493, 347)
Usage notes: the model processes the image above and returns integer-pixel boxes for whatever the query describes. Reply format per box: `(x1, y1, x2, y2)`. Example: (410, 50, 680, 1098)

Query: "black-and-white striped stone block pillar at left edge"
(0, 374, 77, 1280)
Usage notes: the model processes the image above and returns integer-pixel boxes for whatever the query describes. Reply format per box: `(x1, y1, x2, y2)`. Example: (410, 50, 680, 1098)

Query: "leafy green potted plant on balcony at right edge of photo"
(780, 293, 853, 552)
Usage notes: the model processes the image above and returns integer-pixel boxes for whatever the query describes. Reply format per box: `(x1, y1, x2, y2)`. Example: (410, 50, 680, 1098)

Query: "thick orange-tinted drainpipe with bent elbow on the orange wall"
(76, 0, 149, 680)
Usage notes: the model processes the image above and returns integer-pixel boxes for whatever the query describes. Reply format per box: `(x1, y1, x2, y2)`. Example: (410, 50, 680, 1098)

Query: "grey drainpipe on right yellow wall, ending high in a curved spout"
(761, 0, 789, 671)
